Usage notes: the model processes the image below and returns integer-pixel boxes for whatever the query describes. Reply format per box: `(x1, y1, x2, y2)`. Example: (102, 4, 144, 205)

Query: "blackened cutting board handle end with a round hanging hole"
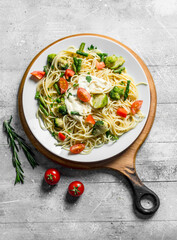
(126, 172, 160, 215)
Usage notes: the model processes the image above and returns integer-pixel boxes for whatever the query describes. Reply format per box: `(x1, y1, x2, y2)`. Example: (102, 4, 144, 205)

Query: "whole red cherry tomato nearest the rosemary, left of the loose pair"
(44, 168, 60, 185)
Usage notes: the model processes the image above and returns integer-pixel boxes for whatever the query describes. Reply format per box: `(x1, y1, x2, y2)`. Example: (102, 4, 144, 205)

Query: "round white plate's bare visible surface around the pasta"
(22, 35, 150, 162)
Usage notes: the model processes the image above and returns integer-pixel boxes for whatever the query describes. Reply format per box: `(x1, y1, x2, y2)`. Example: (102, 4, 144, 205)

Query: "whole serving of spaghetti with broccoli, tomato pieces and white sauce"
(31, 43, 144, 154)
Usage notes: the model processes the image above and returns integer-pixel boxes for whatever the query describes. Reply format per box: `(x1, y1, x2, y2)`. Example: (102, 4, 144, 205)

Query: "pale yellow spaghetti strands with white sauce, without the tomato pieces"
(34, 46, 144, 154)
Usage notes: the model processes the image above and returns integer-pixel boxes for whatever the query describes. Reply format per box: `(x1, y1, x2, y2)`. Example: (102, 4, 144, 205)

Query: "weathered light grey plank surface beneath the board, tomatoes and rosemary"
(0, 0, 177, 240)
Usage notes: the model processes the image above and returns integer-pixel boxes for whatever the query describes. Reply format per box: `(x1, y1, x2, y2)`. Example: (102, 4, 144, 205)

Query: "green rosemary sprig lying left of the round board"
(3, 116, 38, 184)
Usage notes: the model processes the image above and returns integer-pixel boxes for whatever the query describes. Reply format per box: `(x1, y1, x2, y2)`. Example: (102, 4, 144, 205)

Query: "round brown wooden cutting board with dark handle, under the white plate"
(18, 33, 160, 216)
